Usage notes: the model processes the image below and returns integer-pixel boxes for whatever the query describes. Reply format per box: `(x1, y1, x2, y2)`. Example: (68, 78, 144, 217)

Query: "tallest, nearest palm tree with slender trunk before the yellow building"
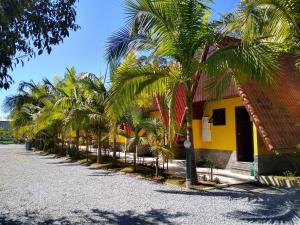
(107, 0, 277, 184)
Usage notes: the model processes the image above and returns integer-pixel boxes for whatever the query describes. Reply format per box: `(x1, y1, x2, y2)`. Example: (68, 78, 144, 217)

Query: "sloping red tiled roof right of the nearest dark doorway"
(239, 56, 300, 150)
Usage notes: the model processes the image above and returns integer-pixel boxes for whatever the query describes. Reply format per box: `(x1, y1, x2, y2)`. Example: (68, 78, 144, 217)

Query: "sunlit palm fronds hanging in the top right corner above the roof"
(229, 0, 300, 71)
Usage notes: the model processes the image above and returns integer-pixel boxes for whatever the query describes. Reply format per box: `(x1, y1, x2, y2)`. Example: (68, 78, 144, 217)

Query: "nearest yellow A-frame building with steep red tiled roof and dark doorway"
(193, 56, 300, 174)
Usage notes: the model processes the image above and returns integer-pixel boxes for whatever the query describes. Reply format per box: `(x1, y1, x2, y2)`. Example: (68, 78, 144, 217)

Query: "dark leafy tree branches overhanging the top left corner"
(0, 0, 79, 89)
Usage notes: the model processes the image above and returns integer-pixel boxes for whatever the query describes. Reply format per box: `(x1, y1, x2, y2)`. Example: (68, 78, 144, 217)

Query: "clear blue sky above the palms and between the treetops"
(0, 0, 239, 117)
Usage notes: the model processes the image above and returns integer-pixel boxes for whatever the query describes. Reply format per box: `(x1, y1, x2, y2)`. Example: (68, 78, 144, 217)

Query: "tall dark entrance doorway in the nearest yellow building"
(235, 107, 254, 162)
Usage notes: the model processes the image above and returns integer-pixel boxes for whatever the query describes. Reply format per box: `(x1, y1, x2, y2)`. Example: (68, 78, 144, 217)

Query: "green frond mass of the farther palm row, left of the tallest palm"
(4, 68, 107, 152)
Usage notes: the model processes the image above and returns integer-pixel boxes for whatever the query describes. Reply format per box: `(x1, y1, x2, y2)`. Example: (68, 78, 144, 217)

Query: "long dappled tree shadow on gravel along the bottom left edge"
(0, 209, 187, 225)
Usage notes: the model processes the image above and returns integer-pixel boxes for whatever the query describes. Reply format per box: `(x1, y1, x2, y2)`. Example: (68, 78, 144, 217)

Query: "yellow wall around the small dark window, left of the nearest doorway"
(193, 97, 243, 151)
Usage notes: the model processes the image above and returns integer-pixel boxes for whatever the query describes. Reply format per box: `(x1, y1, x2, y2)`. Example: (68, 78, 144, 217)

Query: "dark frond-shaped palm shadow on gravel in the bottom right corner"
(157, 189, 300, 225)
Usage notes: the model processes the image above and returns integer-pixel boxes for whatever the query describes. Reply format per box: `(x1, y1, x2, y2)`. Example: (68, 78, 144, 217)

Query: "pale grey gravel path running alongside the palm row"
(0, 145, 300, 225)
